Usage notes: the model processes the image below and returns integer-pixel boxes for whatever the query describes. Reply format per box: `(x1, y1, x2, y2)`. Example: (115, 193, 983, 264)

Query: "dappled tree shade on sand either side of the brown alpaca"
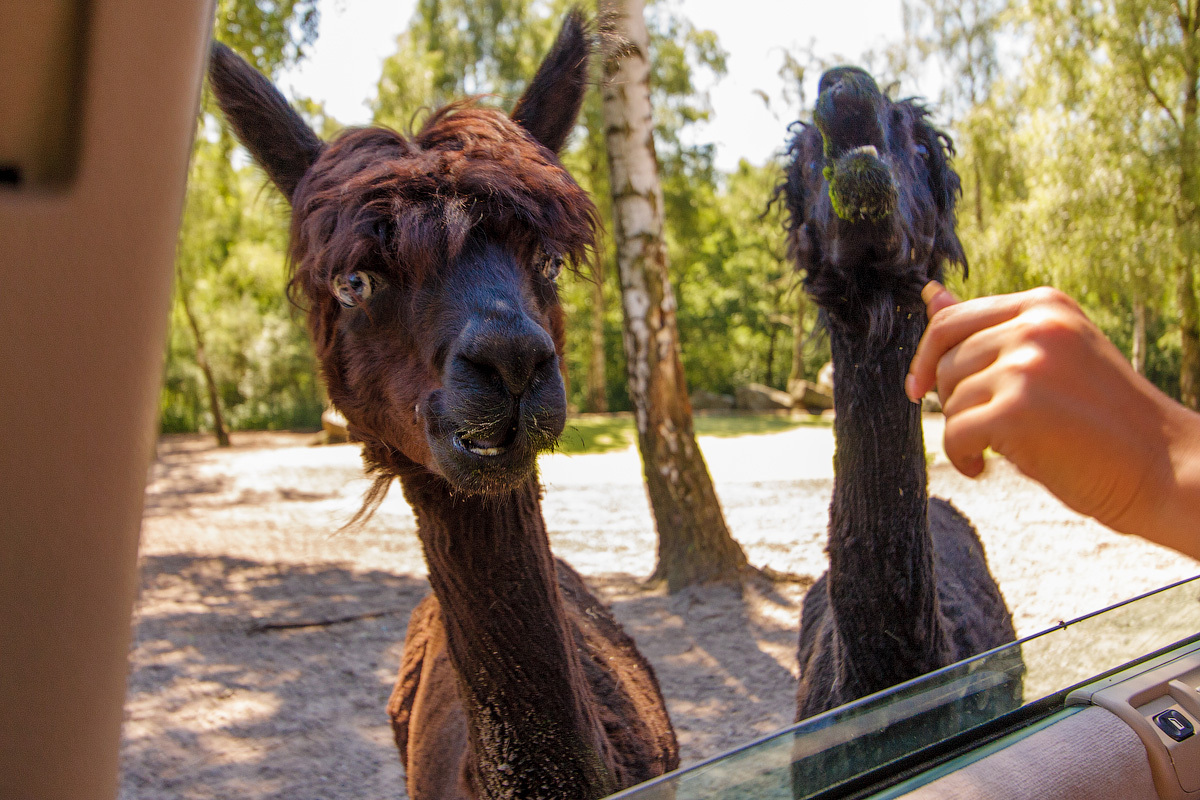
(120, 554, 796, 800)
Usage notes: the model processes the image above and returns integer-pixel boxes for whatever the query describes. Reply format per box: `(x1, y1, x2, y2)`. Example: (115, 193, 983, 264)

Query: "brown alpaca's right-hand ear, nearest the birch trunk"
(512, 8, 592, 152)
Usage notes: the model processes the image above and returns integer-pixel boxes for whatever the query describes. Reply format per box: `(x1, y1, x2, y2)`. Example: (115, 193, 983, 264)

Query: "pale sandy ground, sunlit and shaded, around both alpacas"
(120, 416, 1200, 800)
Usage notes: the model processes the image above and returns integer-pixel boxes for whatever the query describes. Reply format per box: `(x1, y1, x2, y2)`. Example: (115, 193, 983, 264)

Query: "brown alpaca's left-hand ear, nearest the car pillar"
(209, 42, 324, 201)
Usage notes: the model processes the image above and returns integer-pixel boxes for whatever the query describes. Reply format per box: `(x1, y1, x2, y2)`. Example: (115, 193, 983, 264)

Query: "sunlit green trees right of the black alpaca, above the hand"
(905, 0, 1200, 396)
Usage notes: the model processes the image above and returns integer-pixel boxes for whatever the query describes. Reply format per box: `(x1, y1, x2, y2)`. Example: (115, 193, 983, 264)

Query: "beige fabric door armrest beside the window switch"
(904, 706, 1158, 800)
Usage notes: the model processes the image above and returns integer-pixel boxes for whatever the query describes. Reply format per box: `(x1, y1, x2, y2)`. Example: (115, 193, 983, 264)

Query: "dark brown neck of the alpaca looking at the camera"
(404, 479, 618, 800)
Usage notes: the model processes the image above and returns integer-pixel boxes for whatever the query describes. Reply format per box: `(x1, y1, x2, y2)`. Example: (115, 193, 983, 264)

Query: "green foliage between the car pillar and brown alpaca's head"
(161, 144, 324, 432)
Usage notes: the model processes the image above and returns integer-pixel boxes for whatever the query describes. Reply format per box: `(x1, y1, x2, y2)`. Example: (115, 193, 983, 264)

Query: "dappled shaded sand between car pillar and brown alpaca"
(120, 555, 428, 800)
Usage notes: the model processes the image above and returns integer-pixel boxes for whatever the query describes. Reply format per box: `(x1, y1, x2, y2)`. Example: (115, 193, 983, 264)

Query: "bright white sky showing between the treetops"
(280, 0, 902, 170)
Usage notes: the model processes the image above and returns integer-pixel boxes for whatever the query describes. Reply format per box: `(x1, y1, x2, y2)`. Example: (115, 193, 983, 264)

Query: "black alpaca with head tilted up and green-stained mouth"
(780, 67, 1022, 720)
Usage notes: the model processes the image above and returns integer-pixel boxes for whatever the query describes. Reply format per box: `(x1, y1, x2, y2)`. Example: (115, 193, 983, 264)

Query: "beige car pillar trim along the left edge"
(0, 0, 212, 800)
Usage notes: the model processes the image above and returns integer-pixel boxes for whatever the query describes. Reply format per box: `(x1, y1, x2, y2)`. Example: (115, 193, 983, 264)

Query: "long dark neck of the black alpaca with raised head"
(829, 307, 949, 694)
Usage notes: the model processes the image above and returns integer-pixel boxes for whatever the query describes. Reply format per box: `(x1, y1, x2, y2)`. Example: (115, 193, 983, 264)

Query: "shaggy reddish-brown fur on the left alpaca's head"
(285, 102, 596, 499)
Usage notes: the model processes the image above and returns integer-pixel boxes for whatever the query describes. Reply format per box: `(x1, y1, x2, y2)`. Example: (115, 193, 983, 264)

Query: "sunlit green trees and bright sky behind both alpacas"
(174, 0, 1200, 432)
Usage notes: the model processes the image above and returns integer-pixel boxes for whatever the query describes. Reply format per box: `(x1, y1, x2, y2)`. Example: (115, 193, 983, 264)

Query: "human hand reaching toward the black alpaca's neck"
(905, 282, 1200, 552)
